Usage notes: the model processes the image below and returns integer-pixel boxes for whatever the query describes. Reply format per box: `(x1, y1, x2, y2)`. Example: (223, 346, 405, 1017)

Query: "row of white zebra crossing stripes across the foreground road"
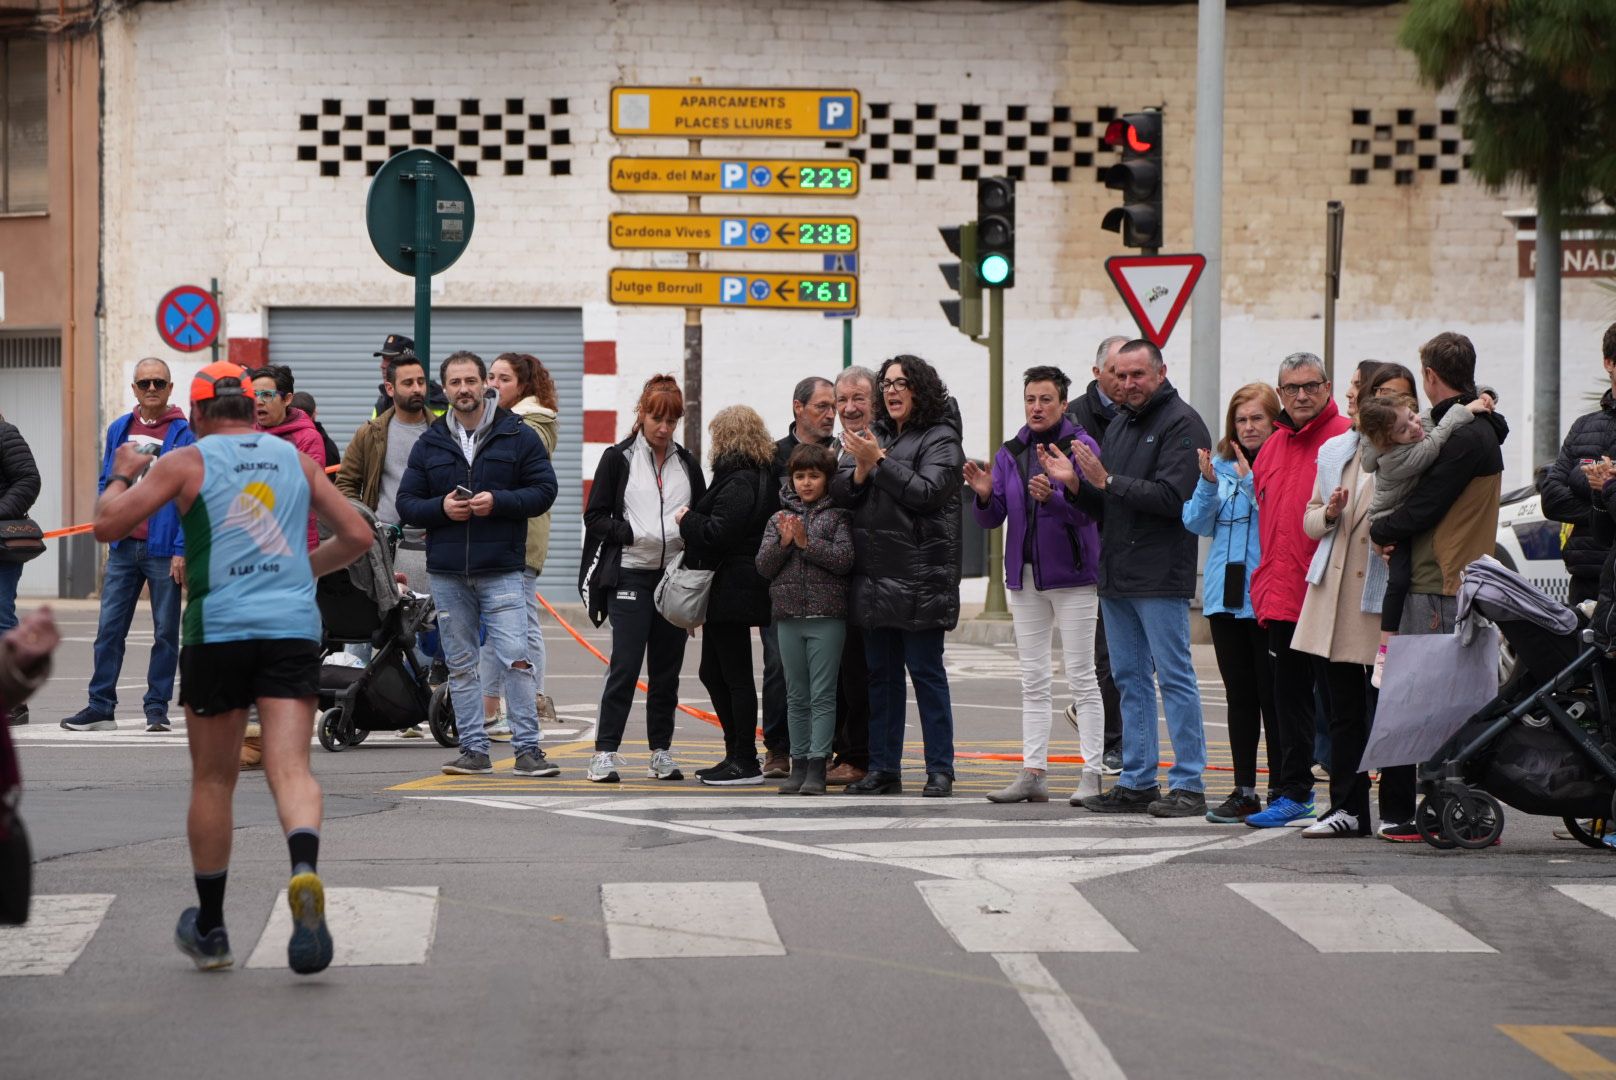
(12, 878, 1616, 978)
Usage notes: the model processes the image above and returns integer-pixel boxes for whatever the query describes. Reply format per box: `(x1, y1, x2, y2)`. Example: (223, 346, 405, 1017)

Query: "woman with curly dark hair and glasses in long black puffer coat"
(832, 356, 965, 797)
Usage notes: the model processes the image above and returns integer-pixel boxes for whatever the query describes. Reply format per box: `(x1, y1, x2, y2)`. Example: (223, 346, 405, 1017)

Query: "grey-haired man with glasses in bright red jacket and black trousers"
(1246, 352, 1353, 829)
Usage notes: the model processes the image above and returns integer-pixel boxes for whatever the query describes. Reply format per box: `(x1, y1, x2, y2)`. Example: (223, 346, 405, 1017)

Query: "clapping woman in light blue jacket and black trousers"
(1185, 383, 1280, 825)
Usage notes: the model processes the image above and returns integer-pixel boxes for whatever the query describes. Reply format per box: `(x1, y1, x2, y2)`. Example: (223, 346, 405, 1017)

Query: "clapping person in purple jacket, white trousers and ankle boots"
(965, 367, 1105, 807)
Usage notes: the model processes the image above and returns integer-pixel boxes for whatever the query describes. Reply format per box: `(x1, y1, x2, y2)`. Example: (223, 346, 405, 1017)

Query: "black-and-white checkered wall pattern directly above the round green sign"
(297, 97, 572, 176)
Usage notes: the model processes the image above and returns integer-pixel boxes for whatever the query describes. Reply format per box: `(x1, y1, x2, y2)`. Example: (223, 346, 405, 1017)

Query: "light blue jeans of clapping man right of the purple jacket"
(1100, 597, 1207, 792)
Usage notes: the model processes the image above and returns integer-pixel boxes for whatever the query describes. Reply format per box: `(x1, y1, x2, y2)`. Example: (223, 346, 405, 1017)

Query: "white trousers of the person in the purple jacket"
(1005, 566, 1105, 773)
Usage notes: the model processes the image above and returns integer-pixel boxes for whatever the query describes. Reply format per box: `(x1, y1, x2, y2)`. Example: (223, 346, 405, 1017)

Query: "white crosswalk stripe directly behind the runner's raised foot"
(247, 884, 438, 967)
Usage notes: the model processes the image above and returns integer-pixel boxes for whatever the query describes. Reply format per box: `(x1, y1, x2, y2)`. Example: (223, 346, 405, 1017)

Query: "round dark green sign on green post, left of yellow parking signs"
(365, 149, 477, 367)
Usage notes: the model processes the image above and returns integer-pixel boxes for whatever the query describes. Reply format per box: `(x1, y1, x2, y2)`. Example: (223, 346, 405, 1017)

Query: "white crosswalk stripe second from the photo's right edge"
(1228, 883, 1496, 952)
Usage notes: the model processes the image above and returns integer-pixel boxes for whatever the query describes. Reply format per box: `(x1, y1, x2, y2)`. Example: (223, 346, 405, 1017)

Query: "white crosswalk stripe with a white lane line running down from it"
(915, 878, 1138, 952)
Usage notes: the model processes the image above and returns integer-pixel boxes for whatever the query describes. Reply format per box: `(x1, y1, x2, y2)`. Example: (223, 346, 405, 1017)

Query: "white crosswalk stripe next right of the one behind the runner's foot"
(601, 881, 785, 960)
